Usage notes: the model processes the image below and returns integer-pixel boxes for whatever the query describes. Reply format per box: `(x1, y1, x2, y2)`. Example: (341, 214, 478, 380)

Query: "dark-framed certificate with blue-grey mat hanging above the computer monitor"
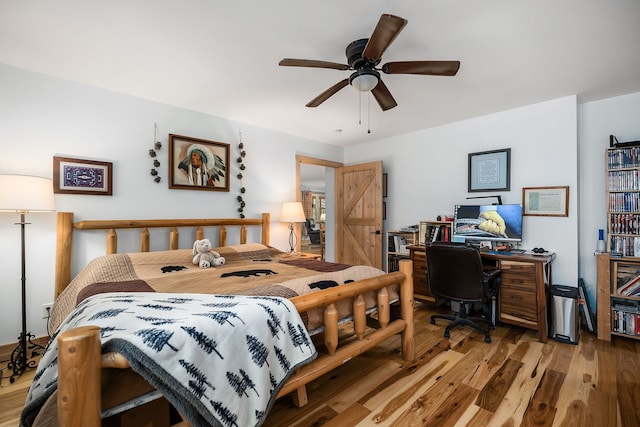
(469, 148, 511, 193)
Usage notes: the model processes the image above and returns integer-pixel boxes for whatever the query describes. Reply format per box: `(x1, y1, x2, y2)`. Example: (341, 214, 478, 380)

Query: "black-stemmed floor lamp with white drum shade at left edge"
(0, 175, 55, 383)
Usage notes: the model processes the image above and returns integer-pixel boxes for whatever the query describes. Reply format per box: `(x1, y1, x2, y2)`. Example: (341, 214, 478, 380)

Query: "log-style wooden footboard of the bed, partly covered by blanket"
(58, 260, 415, 427)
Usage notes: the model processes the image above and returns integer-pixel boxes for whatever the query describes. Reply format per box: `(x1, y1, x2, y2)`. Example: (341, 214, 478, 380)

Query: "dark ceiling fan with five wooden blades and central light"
(279, 14, 460, 111)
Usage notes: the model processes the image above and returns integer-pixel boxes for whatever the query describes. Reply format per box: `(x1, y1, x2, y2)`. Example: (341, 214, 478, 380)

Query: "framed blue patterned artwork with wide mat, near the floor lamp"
(53, 156, 113, 196)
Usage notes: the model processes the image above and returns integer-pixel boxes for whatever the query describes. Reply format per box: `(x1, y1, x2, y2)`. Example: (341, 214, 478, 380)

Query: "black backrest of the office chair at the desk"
(425, 242, 484, 302)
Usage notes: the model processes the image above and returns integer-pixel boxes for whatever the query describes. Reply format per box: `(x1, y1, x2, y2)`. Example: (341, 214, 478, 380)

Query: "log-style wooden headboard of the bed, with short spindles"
(55, 212, 270, 297)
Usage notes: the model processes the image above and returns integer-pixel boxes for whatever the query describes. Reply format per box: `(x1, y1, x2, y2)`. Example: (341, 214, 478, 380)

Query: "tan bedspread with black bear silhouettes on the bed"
(49, 243, 390, 330)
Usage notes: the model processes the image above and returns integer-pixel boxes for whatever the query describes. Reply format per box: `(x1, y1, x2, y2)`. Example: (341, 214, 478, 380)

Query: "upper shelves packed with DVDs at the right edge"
(606, 146, 640, 257)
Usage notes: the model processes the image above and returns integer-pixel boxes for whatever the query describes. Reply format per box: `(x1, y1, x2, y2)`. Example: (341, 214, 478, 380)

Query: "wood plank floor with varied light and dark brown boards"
(0, 304, 640, 427)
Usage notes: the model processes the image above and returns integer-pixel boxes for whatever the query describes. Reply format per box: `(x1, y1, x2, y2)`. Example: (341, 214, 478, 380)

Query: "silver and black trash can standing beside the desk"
(550, 285, 580, 344)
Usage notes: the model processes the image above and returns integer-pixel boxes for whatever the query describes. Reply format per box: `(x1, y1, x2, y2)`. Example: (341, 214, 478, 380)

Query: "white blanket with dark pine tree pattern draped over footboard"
(21, 292, 317, 426)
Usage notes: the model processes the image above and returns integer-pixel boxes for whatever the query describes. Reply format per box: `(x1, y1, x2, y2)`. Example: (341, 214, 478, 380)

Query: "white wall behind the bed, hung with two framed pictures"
(0, 65, 342, 344)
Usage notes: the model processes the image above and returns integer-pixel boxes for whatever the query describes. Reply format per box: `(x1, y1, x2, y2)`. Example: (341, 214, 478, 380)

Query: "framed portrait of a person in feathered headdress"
(169, 134, 229, 191)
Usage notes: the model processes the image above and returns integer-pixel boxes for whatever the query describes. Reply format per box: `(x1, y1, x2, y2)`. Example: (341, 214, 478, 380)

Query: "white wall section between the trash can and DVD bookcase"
(578, 93, 640, 310)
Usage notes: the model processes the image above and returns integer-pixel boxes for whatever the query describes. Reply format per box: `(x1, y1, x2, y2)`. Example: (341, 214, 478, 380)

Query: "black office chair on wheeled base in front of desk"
(425, 242, 501, 343)
